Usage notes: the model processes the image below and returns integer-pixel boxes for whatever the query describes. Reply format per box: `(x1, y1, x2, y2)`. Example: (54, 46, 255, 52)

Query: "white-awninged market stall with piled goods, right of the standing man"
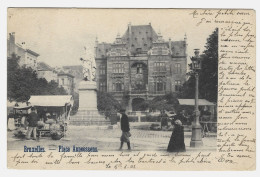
(28, 95, 73, 140)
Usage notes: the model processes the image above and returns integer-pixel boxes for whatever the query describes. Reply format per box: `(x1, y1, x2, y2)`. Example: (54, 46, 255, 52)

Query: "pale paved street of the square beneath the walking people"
(8, 123, 216, 151)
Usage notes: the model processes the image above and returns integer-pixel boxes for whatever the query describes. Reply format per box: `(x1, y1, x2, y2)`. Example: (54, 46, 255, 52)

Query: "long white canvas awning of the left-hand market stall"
(28, 95, 73, 107)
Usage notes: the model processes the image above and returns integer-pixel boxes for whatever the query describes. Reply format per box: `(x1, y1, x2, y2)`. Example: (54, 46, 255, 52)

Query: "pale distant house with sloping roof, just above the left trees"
(37, 62, 58, 82)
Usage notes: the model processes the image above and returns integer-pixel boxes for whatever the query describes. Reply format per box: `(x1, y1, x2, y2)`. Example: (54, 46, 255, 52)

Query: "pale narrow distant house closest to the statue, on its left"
(58, 70, 74, 95)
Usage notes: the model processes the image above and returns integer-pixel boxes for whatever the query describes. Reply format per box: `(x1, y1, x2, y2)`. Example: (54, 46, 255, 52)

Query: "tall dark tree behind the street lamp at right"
(180, 28, 218, 102)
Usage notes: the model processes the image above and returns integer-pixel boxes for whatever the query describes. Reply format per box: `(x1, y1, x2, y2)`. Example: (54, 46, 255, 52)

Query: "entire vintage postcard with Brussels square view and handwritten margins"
(6, 8, 256, 171)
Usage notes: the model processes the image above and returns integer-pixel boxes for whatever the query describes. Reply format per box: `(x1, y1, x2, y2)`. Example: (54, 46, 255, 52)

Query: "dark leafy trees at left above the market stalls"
(7, 54, 67, 102)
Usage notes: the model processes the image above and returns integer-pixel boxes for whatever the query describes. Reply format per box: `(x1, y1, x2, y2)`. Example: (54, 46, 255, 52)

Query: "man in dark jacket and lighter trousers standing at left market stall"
(26, 107, 39, 140)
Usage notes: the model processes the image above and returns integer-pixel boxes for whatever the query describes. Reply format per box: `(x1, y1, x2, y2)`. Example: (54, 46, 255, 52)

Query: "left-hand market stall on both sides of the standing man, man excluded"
(12, 95, 74, 140)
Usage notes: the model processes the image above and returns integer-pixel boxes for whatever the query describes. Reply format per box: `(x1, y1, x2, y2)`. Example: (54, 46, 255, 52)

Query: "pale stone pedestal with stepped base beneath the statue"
(70, 81, 111, 126)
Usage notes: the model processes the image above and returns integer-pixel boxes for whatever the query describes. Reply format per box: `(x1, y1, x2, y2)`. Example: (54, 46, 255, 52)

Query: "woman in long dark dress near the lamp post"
(167, 119, 186, 152)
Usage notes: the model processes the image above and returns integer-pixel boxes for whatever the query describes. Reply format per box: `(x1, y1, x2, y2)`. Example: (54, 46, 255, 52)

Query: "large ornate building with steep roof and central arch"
(95, 24, 187, 111)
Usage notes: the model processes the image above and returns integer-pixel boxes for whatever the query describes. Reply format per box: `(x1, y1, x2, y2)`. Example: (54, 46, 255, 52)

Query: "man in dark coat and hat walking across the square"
(119, 109, 131, 150)
